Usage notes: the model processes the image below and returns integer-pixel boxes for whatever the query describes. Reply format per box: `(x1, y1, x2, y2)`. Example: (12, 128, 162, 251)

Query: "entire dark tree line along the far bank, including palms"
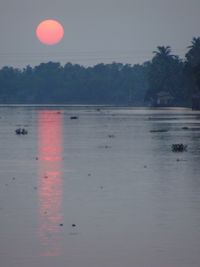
(0, 37, 200, 106)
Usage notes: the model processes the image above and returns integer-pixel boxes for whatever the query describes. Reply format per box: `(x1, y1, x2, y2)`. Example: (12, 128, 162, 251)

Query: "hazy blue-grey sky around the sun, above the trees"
(0, 0, 200, 67)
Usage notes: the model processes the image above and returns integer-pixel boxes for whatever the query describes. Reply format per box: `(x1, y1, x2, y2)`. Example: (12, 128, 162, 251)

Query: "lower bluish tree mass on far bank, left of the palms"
(0, 62, 147, 105)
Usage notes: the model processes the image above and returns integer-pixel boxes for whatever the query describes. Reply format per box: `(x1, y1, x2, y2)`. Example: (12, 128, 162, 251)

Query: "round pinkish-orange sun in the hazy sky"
(36, 19, 64, 45)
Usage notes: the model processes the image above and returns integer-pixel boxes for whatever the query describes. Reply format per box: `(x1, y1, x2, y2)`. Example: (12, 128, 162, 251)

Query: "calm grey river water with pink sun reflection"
(0, 107, 200, 267)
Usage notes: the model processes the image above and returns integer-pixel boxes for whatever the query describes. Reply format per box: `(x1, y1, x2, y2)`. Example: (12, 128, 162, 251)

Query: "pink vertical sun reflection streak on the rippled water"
(38, 110, 63, 256)
